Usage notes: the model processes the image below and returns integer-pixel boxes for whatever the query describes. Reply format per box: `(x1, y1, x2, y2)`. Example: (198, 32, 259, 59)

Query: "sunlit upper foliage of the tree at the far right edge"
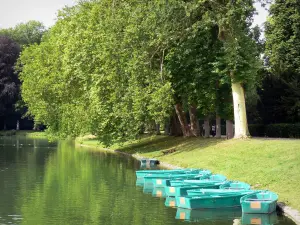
(266, 0, 300, 76)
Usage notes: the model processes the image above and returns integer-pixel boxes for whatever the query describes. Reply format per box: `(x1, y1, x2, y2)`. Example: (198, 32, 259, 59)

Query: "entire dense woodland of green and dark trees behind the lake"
(0, 0, 300, 144)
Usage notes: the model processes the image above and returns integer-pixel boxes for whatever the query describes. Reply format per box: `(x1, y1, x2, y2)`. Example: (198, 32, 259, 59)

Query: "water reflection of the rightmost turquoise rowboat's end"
(242, 212, 278, 225)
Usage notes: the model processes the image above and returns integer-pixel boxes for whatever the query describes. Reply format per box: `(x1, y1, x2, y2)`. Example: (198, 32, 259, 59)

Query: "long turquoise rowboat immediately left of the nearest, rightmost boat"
(176, 190, 255, 209)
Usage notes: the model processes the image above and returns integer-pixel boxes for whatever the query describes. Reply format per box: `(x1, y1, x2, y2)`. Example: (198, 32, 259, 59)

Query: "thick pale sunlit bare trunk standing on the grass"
(231, 83, 250, 138)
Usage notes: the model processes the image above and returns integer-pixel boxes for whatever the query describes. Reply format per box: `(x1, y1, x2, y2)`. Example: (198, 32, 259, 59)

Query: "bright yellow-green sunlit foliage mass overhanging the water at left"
(20, 1, 176, 143)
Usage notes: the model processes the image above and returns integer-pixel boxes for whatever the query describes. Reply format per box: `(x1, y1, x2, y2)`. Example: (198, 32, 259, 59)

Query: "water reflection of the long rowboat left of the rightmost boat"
(175, 207, 242, 222)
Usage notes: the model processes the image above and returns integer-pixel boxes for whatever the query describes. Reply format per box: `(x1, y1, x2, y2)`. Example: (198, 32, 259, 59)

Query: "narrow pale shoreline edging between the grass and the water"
(75, 143, 300, 225)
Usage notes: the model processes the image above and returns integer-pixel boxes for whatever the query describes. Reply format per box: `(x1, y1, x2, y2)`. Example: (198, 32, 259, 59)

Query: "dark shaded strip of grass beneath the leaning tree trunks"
(118, 135, 226, 156)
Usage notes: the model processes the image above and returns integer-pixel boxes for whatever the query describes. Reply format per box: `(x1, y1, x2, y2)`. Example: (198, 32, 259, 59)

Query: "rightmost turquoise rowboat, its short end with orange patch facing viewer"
(240, 191, 278, 213)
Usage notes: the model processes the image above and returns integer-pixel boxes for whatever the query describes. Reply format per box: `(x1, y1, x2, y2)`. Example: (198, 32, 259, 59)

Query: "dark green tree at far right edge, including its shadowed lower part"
(265, 0, 300, 122)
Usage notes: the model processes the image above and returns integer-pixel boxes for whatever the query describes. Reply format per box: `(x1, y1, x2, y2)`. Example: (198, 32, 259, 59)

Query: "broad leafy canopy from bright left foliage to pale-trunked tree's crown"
(19, 0, 258, 144)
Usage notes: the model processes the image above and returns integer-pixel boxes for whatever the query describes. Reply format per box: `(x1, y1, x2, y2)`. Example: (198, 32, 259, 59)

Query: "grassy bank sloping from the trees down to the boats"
(80, 136, 300, 210)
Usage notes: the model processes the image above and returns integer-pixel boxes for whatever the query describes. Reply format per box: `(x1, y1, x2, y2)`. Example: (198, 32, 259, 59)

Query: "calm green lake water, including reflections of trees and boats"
(0, 135, 294, 225)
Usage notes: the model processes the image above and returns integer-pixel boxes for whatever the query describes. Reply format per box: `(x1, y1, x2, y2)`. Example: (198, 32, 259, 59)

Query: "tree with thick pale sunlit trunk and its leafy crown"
(191, 0, 260, 138)
